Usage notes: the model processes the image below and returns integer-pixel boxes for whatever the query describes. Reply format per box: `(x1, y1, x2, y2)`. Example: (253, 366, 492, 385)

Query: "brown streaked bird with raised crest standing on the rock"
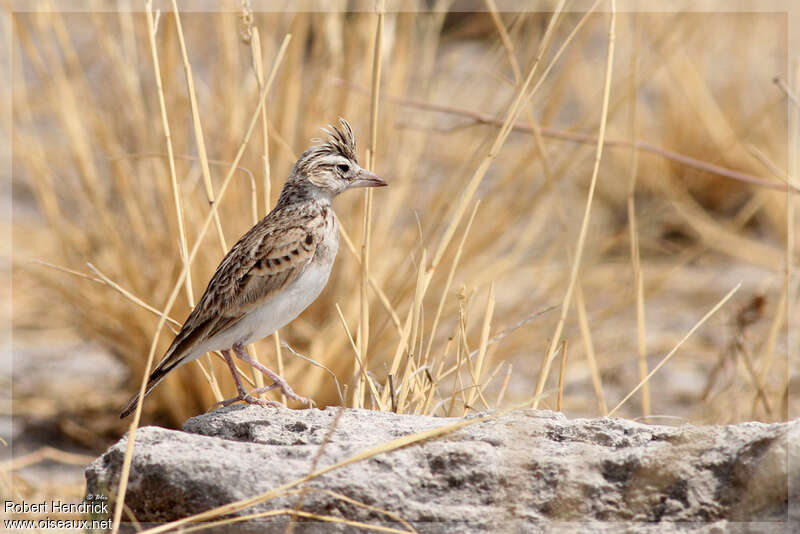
(120, 118, 388, 419)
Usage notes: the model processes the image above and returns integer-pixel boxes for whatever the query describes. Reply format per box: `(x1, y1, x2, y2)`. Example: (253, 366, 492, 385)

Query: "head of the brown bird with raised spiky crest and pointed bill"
(282, 118, 387, 204)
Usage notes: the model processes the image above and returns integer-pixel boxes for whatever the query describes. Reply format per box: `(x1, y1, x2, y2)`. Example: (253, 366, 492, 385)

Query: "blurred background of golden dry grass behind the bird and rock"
(0, 0, 800, 520)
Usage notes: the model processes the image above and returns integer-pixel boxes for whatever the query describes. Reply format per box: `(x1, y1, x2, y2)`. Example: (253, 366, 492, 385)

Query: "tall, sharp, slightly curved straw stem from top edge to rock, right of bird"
(532, 0, 616, 409)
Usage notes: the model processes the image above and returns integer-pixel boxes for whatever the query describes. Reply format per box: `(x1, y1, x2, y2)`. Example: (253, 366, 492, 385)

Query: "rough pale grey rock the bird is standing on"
(86, 406, 800, 533)
